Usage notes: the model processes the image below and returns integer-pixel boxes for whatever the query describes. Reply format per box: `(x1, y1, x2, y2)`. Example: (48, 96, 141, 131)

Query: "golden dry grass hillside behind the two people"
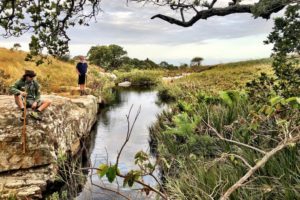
(0, 48, 102, 93)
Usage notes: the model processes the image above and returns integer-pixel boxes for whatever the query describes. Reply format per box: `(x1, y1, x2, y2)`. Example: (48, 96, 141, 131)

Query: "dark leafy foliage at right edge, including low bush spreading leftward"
(248, 4, 300, 101)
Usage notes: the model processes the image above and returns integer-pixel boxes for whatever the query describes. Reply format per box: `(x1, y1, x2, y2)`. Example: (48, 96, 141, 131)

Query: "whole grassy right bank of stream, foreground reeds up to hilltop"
(150, 60, 300, 200)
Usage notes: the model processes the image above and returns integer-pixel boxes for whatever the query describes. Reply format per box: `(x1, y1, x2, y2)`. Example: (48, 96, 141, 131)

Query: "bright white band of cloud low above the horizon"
(105, 35, 271, 64)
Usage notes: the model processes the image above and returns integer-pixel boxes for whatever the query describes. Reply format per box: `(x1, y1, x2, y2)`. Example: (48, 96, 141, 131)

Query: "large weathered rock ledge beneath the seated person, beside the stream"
(0, 95, 98, 199)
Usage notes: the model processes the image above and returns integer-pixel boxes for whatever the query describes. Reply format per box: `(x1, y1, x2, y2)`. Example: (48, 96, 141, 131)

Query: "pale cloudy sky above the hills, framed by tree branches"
(0, 0, 282, 65)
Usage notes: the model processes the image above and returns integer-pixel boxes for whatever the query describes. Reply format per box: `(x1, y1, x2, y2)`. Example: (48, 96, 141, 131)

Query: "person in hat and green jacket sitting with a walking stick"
(10, 70, 51, 120)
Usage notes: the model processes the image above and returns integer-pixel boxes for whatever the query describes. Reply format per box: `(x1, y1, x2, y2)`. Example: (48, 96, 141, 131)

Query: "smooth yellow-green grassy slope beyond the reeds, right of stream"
(174, 59, 273, 93)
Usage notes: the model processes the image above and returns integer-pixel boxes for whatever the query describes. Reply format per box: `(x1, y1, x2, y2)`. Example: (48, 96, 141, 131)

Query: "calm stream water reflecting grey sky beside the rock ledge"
(77, 89, 164, 200)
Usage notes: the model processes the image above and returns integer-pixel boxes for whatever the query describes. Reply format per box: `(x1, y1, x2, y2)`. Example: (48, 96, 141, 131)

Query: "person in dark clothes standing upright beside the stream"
(76, 56, 88, 96)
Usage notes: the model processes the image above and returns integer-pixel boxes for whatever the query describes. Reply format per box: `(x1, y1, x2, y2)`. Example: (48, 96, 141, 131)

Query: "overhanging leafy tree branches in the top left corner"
(0, 0, 101, 60)
